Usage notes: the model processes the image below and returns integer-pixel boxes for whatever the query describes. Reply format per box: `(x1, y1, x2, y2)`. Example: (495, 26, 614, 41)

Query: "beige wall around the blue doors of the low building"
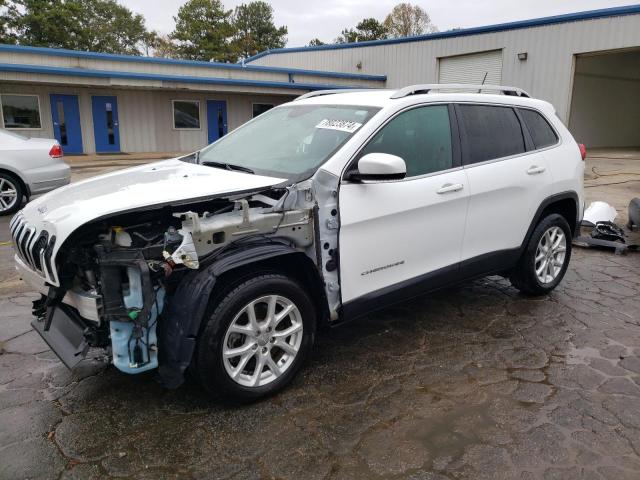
(0, 83, 294, 153)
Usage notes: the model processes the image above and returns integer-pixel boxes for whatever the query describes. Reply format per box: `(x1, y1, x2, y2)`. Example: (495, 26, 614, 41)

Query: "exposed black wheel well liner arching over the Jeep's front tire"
(158, 239, 328, 388)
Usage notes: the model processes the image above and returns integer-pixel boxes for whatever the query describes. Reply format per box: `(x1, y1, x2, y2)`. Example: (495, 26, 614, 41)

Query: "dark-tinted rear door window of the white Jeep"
(458, 105, 526, 164)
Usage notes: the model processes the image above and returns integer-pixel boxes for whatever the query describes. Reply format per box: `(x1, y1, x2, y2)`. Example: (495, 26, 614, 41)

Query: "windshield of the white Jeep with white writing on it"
(192, 105, 379, 180)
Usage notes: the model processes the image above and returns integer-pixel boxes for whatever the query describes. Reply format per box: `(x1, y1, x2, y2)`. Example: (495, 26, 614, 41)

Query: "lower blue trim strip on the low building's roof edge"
(0, 63, 362, 90)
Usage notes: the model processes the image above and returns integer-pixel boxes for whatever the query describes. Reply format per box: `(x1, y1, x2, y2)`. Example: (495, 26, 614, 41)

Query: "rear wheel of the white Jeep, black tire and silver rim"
(509, 213, 572, 296)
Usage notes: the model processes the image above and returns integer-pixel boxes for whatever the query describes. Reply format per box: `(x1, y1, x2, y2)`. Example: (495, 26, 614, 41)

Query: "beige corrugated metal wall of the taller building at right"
(251, 15, 640, 122)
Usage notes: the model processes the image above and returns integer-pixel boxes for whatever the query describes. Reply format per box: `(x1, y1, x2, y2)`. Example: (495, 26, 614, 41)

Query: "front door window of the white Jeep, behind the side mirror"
(359, 105, 453, 177)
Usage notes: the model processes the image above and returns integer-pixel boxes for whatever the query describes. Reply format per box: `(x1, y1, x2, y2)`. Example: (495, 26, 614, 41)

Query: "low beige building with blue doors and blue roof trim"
(0, 45, 386, 155)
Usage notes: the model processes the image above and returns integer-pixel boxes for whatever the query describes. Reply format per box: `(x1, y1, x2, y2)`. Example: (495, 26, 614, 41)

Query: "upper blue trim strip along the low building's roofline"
(0, 44, 387, 82)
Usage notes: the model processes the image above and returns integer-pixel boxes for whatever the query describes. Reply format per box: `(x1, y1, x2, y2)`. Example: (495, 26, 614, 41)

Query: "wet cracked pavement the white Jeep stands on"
(0, 156, 640, 480)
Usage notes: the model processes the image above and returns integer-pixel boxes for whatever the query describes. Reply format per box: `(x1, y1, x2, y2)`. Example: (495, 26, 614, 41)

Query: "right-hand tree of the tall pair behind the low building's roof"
(233, 1, 288, 58)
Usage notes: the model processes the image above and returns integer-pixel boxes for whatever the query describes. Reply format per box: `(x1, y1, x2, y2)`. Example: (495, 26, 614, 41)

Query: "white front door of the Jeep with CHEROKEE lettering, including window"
(340, 105, 469, 308)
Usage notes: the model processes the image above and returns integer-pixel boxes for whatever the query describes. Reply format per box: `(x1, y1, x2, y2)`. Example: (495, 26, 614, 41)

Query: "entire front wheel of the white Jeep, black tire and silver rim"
(195, 274, 316, 402)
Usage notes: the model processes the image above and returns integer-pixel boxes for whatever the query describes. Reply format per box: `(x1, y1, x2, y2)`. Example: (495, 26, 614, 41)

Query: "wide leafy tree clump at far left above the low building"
(0, 0, 147, 55)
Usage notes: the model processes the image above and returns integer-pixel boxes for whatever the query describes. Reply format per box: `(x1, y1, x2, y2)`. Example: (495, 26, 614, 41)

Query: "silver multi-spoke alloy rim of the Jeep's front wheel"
(222, 295, 303, 387)
